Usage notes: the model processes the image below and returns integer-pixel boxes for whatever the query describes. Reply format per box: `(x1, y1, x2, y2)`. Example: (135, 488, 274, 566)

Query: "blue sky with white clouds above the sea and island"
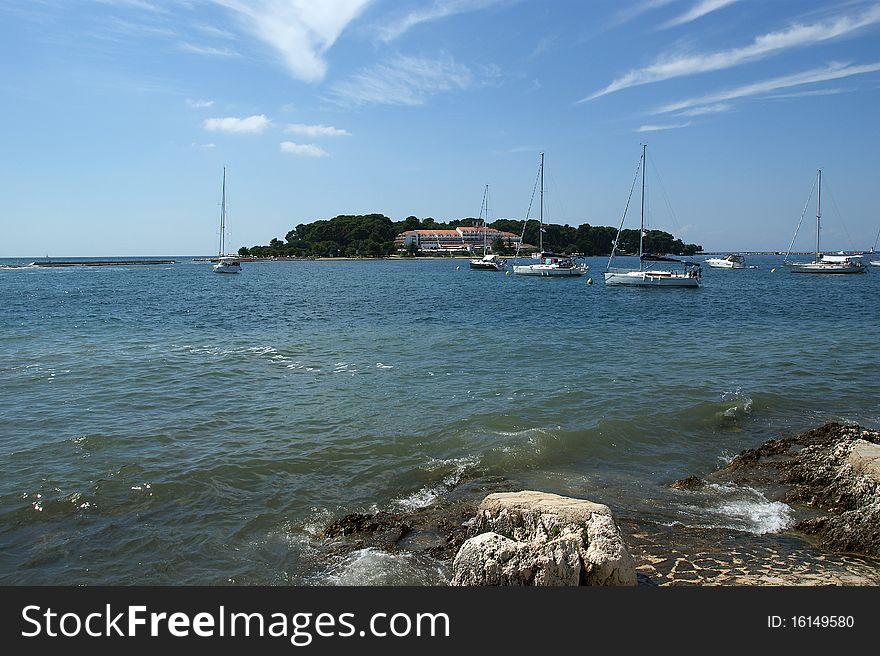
(0, 0, 880, 257)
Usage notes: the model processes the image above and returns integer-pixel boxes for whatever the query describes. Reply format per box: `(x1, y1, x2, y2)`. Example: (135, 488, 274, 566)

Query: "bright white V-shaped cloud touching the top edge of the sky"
(213, 0, 372, 82)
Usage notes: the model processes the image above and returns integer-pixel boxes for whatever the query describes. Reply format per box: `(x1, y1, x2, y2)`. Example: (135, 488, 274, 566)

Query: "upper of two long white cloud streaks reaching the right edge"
(578, 5, 880, 103)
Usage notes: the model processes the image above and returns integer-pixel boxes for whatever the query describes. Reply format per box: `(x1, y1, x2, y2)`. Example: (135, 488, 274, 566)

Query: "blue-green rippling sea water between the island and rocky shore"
(0, 255, 880, 585)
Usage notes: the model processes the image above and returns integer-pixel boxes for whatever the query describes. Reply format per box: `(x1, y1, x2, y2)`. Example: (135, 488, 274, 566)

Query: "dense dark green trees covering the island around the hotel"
(238, 214, 703, 257)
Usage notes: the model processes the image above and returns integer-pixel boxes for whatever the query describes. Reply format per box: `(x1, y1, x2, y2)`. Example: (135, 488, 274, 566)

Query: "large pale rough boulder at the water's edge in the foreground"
(452, 491, 636, 586)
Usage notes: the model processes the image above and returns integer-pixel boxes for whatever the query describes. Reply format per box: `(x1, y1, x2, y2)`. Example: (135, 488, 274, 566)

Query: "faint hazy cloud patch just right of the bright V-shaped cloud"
(331, 55, 473, 105)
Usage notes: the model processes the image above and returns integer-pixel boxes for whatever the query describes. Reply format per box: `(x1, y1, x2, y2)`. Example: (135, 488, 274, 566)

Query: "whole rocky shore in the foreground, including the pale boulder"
(323, 424, 880, 585)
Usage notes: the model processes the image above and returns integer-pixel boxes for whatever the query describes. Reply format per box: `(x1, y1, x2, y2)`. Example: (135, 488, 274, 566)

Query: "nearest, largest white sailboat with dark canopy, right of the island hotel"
(605, 144, 701, 287)
